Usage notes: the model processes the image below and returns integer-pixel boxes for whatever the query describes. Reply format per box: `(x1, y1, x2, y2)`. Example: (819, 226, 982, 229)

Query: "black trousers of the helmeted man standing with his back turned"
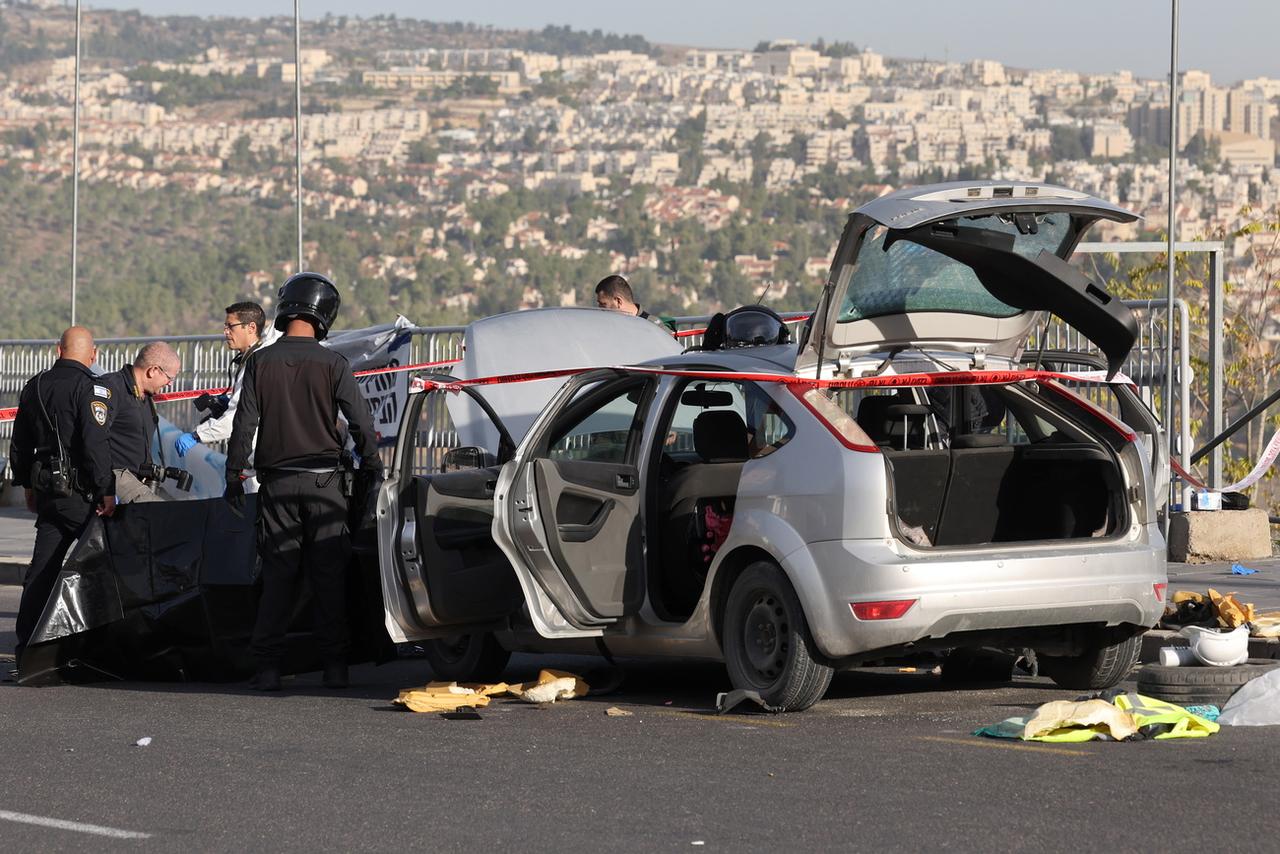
(251, 471, 351, 667)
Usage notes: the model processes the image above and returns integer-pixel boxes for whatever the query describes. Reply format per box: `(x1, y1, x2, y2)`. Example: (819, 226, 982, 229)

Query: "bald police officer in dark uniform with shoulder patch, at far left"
(10, 326, 115, 667)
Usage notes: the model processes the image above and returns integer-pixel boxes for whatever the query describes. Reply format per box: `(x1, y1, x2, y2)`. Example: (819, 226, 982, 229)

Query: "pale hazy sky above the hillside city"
(88, 0, 1280, 83)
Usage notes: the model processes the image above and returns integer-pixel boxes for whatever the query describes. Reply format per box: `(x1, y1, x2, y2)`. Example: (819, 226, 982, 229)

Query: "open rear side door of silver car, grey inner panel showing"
(494, 370, 655, 638)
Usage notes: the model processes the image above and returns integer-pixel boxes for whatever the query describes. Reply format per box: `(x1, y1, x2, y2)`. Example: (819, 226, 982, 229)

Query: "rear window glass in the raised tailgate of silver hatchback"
(840, 213, 1071, 323)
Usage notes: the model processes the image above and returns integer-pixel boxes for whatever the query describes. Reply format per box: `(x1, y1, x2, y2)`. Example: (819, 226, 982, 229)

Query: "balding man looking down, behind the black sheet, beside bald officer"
(101, 341, 182, 504)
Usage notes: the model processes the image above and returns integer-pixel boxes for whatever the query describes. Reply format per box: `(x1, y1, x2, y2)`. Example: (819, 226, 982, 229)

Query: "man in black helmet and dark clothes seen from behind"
(227, 273, 381, 691)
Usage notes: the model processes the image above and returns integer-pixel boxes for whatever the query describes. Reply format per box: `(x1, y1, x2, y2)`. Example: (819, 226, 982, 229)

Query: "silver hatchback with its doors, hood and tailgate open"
(379, 182, 1166, 711)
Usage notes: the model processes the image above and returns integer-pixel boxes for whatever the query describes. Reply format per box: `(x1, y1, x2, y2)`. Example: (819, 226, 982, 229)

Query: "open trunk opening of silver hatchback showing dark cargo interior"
(858, 384, 1129, 548)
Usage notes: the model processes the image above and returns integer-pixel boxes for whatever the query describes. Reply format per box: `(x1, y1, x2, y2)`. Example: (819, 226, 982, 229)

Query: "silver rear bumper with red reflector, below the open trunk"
(786, 536, 1167, 658)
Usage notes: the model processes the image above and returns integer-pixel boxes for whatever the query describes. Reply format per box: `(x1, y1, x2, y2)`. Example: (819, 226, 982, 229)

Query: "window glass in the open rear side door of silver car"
(547, 380, 649, 463)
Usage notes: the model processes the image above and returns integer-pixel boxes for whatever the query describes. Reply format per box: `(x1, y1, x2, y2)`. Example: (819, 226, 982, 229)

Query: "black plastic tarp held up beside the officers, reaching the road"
(19, 495, 393, 685)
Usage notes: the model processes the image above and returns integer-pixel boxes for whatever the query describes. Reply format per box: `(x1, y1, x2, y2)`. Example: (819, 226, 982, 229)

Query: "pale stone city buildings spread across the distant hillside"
(0, 19, 1280, 313)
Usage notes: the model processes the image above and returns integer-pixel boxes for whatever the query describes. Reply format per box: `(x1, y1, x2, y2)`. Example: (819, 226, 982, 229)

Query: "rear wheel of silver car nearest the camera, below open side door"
(723, 561, 835, 712)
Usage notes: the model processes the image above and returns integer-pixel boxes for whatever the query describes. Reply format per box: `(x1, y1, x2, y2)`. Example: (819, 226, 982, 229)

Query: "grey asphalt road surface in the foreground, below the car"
(0, 586, 1280, 851)
